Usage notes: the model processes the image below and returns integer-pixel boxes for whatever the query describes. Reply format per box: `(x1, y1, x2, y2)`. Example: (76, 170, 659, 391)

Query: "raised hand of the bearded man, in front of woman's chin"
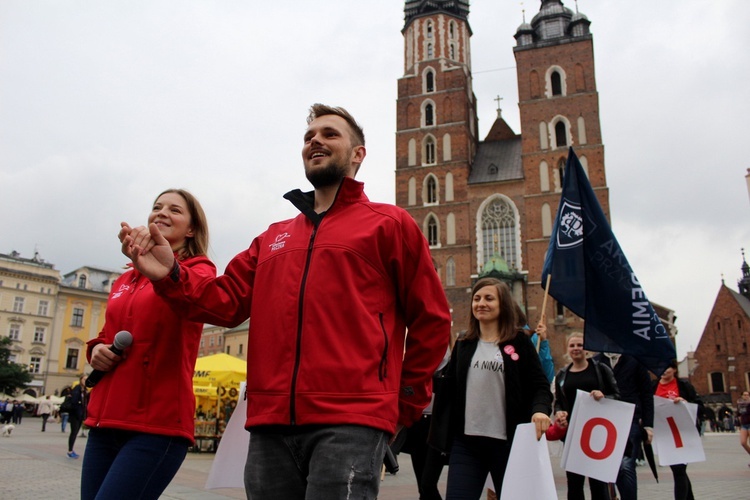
(118, 222, 174, 281)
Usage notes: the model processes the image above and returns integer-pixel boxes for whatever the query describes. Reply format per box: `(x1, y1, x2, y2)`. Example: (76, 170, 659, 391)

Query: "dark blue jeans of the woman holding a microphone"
(81, 429, 190, 500)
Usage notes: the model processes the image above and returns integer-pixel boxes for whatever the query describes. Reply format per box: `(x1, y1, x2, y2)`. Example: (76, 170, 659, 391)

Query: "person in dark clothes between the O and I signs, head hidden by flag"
(594, 353, 654, 500)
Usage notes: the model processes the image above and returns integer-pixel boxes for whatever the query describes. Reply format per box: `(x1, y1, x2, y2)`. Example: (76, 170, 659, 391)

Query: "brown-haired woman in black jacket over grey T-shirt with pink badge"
(446, 278, 552, 500)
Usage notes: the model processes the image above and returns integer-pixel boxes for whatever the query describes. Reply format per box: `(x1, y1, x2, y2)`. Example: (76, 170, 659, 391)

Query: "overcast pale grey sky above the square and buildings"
(0, 0, 750, 356)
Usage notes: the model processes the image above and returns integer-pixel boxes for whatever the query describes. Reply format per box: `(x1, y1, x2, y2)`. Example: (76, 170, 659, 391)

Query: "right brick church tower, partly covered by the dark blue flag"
(513, 0, 609, 344)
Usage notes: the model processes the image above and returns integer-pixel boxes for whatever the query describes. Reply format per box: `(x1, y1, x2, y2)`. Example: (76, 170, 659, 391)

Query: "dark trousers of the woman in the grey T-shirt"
(445, 435, 510, 500)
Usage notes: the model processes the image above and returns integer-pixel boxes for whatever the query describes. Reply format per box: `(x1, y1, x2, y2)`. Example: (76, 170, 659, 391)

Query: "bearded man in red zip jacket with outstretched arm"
(120, 104, 450, 499)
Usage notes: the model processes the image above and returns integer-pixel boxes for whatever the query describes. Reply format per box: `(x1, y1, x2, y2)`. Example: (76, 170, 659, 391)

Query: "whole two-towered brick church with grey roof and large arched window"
(396, 0, 609, 365)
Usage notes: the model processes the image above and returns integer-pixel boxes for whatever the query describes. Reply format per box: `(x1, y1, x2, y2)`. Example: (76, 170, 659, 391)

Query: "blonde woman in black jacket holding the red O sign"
(555, 332, 619, 500)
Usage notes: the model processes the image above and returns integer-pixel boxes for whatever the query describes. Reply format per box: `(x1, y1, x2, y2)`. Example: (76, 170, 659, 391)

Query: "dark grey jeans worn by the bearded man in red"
(245, 425, 388, 500)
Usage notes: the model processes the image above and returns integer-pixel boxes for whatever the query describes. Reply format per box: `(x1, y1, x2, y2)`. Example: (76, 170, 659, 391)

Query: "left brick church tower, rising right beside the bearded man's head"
(396, 0, 478, 320)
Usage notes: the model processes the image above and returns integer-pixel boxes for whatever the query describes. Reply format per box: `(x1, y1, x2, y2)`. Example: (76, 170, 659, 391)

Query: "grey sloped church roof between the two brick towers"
(469, 136, 523, 184)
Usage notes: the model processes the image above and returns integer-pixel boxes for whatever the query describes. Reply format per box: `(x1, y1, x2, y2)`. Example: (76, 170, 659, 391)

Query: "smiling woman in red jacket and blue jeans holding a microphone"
(81, 189, 216, 499)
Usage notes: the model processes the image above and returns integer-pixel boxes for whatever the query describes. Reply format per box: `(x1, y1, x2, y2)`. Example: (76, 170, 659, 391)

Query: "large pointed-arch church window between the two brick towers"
(480, 198, 520, 269)
